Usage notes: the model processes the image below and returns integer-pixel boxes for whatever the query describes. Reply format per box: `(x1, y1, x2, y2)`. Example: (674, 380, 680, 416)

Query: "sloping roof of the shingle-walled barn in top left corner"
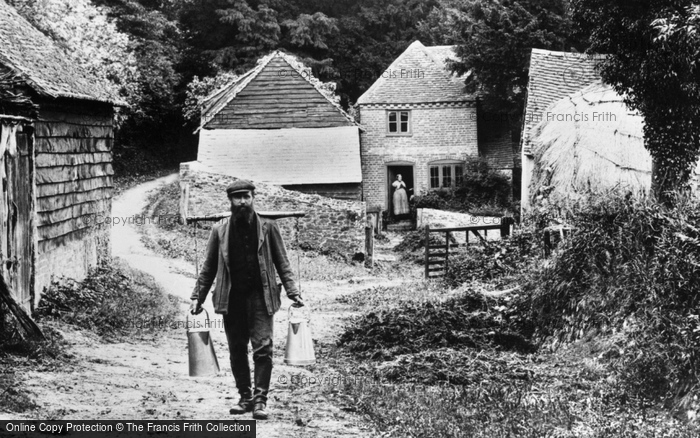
(0, 0, 117, 103)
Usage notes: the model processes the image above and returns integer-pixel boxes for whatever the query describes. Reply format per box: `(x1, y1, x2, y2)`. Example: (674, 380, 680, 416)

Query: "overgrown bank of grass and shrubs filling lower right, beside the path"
(339, 193, 700, 437)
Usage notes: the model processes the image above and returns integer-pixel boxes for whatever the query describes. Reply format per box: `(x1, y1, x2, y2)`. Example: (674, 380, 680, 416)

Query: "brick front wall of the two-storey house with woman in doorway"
(360, 102, 479, 210)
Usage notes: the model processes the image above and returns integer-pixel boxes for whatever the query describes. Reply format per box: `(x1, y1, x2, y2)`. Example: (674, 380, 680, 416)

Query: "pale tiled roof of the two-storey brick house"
(357, 41, 475, 105)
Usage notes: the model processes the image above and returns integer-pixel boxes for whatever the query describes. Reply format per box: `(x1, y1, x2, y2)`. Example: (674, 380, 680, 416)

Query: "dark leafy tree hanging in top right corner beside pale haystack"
(572, 0, 700, 204)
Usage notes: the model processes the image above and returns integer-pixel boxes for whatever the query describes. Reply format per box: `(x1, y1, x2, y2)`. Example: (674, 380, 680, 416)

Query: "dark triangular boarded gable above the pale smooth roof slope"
(205, 57, 353, 129)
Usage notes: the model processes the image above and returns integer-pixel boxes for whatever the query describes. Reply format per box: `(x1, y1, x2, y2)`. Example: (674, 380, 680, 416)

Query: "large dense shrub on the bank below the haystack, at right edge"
(528, 197, 700, 399)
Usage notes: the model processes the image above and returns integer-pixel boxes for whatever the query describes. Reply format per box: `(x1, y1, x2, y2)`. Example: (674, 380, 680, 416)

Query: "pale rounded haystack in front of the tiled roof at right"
(530, 81, 700, 204)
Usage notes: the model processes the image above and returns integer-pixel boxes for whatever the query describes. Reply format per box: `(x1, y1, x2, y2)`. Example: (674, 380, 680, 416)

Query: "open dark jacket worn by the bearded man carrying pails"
(191, 213, 299, 315)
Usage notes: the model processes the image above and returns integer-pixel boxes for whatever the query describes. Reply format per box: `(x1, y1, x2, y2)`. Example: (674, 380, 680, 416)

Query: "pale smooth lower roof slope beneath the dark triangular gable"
(197, 126, 362, 185)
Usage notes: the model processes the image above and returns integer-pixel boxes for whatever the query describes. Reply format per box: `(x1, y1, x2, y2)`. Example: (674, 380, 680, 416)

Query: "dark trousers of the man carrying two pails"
(224, 291, 274, 403)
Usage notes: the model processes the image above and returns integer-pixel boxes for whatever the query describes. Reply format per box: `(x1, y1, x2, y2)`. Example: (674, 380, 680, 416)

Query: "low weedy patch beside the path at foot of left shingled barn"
(36, 259, 180, 339)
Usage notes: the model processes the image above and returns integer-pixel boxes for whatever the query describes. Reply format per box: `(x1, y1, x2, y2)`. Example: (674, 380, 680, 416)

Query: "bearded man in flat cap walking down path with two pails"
(190, 180, 304, 420)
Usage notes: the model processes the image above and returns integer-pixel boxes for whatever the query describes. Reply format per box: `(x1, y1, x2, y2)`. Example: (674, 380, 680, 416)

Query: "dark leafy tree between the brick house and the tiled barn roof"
(438, 0, 580, 139)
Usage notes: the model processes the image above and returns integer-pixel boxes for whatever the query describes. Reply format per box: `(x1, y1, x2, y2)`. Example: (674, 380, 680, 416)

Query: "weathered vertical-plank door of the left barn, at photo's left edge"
(0, 125, 35, 313)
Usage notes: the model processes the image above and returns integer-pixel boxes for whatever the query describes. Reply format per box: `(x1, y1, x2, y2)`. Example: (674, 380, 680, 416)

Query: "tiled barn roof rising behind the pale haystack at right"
(521, 49, 602, 155)
